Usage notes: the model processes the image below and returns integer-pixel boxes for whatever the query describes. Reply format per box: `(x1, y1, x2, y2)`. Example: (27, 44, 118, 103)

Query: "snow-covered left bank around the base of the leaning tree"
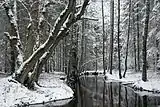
(0, 73, 73, 107)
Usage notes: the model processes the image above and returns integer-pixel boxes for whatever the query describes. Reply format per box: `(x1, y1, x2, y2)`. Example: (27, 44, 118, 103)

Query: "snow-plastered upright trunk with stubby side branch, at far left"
(4, 0, 23, 74)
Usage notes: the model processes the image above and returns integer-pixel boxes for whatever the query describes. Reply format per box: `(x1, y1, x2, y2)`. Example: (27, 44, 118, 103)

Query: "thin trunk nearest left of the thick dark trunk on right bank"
(136, 3, 140, 72)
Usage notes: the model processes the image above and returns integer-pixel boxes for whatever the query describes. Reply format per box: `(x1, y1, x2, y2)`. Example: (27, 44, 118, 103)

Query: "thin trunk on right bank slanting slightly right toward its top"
(123, 0, 131, 78)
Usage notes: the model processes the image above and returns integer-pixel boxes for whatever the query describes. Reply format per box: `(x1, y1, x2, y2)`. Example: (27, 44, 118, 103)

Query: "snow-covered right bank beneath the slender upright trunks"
(83, 70, 160, 92)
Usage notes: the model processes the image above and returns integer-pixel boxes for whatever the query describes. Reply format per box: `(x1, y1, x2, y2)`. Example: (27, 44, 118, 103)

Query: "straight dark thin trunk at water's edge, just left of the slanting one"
(117, 0, 122, 79)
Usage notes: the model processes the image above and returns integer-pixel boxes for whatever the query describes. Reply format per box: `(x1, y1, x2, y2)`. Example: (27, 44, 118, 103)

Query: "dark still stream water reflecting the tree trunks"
(63, 76, 160, 107)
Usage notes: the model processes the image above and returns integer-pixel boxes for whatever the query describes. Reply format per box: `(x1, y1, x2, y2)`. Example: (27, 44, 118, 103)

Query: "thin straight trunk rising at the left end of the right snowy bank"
(102, 0, 106, 75)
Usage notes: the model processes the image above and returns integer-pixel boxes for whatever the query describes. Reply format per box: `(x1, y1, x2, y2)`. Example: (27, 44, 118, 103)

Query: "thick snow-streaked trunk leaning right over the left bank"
(13, 0, 89, 86)
